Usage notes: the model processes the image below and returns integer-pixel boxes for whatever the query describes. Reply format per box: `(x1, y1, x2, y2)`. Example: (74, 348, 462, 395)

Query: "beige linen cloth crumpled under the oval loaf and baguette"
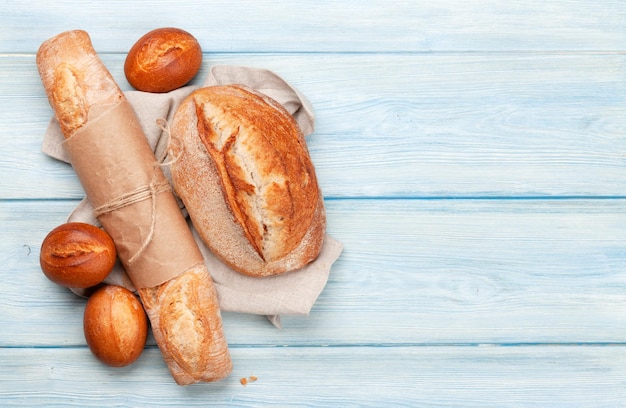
(42, 65, 343, 328)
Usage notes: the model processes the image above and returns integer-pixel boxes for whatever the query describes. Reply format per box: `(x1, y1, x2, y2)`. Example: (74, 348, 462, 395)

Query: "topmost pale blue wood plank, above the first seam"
(0, 0, 626, 52)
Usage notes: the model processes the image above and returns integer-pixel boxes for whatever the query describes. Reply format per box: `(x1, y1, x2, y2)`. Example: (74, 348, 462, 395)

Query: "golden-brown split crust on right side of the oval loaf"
(194, 87, 318, 261)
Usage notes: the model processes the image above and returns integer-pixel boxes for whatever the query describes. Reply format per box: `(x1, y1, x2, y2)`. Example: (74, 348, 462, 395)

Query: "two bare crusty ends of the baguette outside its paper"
(37, 31, 232, 385)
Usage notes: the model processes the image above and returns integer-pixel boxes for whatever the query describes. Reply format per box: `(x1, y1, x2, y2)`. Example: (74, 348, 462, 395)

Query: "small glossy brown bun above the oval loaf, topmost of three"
(124, 27, 202, 93)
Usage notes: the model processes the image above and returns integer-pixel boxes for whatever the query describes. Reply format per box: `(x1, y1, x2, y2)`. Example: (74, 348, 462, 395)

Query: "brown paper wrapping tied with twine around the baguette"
(63, 101, 203, 288)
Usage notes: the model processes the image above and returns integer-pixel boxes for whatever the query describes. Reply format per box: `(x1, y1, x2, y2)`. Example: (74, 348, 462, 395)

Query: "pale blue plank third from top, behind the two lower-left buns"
(0, 199, 626, 347)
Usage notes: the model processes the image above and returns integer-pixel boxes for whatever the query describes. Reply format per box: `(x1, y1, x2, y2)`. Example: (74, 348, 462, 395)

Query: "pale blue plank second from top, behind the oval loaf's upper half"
(0, 54, 626, 198)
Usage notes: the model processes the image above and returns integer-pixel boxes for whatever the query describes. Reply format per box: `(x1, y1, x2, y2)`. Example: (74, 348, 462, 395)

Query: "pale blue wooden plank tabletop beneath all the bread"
(0, 0, 626, 407)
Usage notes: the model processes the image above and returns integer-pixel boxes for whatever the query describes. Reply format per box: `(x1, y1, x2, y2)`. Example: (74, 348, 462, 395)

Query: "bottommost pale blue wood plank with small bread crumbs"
(0, 346, 626, 408)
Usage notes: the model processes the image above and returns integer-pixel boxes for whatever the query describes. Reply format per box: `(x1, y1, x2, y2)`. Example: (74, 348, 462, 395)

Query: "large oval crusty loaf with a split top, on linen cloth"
(169, 85, 326, 276)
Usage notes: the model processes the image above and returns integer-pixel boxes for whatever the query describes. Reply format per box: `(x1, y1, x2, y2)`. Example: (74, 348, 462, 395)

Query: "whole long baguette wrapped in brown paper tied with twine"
(37, 30, 232, 385)
